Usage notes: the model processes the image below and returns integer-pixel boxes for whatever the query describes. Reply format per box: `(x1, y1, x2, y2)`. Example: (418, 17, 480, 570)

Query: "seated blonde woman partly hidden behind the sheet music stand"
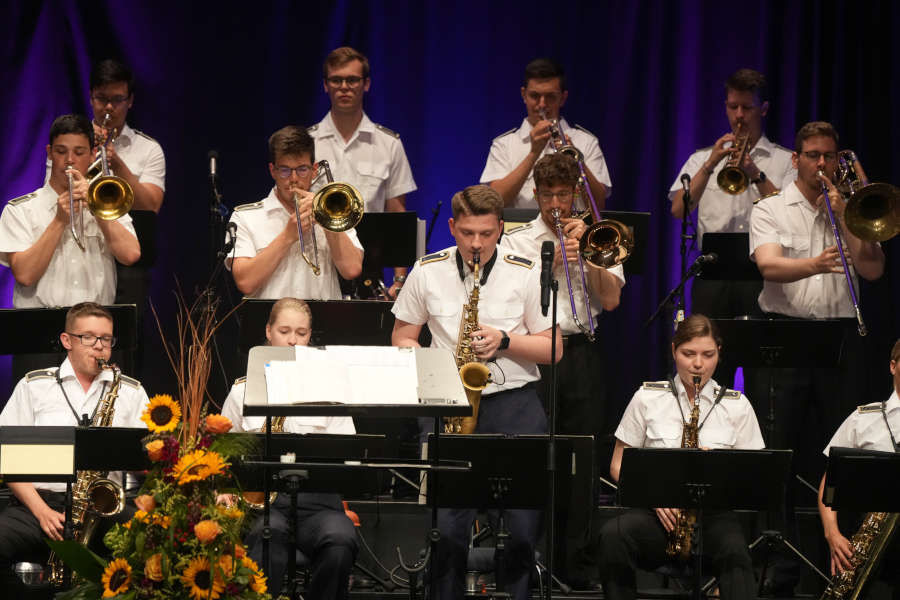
(222, 298, 359, 598)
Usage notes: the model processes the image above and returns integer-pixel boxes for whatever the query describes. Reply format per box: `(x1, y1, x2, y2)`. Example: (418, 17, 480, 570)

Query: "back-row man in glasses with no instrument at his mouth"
(308, 46, 416, 299)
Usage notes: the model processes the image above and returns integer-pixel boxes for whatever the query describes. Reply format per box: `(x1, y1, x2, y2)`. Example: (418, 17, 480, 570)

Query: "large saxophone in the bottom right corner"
(819, 512, 898, 600)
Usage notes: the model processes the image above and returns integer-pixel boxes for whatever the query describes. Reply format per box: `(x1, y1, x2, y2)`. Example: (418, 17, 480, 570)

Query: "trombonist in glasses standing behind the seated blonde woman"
(225, 125, 363, 300)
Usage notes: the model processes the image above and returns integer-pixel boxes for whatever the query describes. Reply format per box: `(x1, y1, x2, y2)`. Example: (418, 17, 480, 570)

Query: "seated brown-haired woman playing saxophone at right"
(600, 315, 763, 600)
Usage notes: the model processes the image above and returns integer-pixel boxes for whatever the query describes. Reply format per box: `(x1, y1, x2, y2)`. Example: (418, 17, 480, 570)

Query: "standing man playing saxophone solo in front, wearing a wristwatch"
(391, 185, 563, 600)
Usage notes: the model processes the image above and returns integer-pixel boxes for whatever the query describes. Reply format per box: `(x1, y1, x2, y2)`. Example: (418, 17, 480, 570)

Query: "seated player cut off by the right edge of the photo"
(819, 340, 900, 596)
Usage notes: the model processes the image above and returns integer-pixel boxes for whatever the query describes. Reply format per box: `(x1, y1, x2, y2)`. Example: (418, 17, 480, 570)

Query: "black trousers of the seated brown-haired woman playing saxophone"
(600, 509, 756, 600)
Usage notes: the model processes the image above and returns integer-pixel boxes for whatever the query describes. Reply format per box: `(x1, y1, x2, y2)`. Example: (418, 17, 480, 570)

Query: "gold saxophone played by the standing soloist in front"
(444, 253, 491, 433)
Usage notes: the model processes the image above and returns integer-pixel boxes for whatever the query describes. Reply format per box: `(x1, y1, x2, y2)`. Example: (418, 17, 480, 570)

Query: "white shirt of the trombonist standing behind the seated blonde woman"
(231, 187, 362, 300)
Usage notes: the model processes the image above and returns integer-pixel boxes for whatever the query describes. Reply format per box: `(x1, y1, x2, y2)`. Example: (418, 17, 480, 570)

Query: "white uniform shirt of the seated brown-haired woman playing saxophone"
(616, 377, 765, 450)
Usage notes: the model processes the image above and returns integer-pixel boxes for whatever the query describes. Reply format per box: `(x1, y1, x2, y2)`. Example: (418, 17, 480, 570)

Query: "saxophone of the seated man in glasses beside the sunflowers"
(47, 358, 125, 587)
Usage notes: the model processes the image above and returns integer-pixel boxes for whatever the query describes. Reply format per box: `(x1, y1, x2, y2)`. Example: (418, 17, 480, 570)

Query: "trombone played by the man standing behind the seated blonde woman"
(292, 160, 366, 275)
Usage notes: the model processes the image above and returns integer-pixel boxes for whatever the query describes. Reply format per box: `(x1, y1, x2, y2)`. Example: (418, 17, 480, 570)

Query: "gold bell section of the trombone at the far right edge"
(837, 150, 900, 242)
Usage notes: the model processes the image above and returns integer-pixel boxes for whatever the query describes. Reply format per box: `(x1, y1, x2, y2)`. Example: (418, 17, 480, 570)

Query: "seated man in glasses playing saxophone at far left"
(0, 302, 149, 571)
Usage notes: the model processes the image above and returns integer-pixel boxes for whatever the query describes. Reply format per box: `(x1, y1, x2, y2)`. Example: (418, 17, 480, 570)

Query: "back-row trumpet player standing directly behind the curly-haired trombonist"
(481, 58, 612, 210)
